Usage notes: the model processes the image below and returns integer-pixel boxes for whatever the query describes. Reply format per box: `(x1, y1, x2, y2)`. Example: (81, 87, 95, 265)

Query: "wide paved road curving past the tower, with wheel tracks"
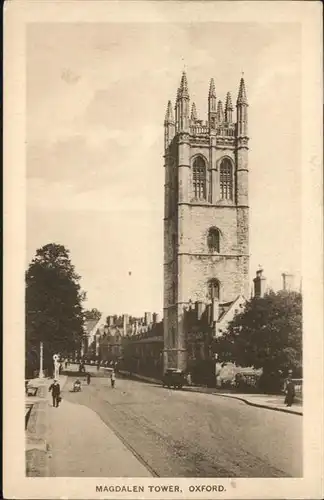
(64, 373, 303, 477)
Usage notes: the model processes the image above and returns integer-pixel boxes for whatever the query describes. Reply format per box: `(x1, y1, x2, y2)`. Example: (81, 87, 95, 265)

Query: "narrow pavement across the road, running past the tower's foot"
(121, 372, 303, 416)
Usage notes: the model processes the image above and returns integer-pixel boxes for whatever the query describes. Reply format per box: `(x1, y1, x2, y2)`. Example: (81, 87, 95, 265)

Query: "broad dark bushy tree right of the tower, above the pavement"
(215, 291, 302, 382)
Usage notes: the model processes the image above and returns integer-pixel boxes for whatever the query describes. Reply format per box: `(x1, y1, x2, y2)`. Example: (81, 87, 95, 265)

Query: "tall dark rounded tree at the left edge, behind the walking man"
(26, 243, 85, 376)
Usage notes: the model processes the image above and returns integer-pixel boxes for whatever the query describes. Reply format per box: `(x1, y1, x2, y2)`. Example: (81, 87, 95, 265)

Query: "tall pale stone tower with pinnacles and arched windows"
(164, 73, 249, 369)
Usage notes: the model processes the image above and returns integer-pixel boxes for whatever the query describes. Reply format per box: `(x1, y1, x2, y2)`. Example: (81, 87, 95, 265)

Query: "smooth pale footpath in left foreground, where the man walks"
(47, 397, 152, 477)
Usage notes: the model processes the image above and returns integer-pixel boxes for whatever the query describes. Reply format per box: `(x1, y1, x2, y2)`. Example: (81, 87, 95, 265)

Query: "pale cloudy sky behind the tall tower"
(26, 22, 302, 316)
